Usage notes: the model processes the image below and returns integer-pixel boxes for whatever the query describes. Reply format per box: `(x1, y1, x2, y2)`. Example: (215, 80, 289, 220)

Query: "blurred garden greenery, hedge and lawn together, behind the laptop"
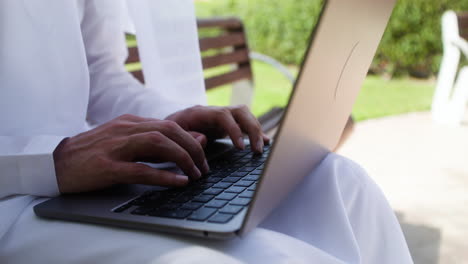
(195, 0, 468, 121)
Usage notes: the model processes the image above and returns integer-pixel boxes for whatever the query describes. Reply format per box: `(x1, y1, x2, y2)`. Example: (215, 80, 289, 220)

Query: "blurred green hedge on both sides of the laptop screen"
(196, 0, 468, 76)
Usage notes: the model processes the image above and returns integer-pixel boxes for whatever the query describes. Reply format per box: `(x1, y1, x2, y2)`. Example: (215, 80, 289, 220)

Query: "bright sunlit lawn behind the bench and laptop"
(205, 62, 434, 121)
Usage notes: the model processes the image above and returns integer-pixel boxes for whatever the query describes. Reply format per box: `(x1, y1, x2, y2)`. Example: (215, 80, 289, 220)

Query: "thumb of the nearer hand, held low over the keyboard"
(116, 162, 189, 187)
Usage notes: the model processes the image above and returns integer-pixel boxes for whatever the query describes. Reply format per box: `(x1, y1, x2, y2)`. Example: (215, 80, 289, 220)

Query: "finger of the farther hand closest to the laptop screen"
(231, 107, 264, 153)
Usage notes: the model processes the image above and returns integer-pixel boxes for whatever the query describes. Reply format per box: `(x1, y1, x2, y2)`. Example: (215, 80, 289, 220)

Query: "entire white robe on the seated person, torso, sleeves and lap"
(0, 0, 411, 263)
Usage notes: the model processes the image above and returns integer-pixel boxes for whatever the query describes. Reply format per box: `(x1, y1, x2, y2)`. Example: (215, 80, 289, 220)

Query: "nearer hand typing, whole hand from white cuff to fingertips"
(54, 115, 209, 193)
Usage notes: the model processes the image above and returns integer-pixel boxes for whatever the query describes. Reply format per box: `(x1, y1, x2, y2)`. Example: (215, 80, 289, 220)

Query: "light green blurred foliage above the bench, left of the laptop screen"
(196, 0, 322, 65)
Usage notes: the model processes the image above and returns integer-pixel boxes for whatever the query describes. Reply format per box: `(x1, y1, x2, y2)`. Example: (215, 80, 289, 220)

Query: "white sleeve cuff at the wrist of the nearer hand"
(0, 135, 64, 198)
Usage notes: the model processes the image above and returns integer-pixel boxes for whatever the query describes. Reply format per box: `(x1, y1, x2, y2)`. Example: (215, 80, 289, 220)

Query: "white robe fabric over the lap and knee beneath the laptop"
(0, 154, 412, 264)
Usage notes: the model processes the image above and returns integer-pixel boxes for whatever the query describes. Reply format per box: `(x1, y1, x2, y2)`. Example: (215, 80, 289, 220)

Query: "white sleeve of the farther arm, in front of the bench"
(81, 0, 189, 124)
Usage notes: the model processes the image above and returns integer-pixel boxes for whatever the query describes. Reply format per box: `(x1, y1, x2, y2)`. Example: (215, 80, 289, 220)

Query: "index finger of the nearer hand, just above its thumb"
(126, 131, 201, 179)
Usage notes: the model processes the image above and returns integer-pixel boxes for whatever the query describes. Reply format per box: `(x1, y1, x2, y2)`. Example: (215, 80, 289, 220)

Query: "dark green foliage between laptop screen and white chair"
(372, 0, 468, 76)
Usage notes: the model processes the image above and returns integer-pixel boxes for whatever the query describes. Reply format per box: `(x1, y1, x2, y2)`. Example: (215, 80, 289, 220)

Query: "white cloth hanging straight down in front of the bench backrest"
(124, 0, 206, 104)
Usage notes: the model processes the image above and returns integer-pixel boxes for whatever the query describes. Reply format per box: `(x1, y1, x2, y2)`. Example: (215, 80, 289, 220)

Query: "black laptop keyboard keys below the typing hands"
(114, 145, 270, 223)
